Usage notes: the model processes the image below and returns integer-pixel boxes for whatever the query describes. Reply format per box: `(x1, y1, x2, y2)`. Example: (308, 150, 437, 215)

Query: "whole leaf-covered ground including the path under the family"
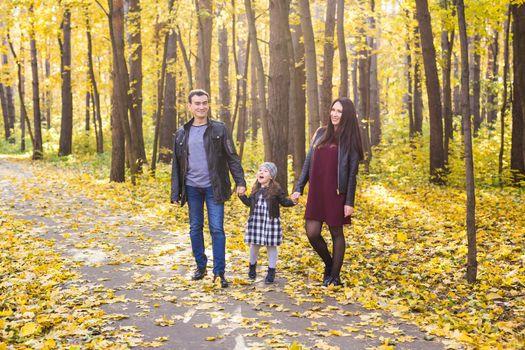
(0, 156, 524, 349)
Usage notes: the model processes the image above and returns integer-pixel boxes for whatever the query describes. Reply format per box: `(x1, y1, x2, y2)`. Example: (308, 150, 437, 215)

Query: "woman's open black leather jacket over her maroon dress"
(294, 128, 360, 207)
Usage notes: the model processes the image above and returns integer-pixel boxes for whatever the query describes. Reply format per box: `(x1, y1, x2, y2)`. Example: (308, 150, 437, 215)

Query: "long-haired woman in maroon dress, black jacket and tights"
(291, 97, 363, 286)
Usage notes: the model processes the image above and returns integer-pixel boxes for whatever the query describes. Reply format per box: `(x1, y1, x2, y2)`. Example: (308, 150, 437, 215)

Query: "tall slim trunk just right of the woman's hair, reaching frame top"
(367, 0, 381, 146)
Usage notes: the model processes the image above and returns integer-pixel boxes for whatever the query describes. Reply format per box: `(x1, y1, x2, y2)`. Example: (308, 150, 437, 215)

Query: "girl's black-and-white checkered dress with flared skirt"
(244, 194, 283, 246)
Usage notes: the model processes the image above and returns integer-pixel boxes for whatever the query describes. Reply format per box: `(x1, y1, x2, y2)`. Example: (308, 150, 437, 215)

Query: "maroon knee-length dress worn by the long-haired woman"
(304, 145, 351, 226)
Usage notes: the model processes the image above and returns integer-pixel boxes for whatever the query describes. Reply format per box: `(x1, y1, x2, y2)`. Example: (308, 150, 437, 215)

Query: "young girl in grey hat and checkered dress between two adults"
(239, 162, 297, 284)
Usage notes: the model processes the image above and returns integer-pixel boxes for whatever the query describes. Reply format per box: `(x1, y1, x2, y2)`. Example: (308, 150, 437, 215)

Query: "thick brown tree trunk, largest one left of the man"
(108, 0, 138, 184)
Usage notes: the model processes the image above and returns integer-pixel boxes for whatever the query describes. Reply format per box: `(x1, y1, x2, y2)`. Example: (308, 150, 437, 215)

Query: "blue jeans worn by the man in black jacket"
(186, 186, 226, 274)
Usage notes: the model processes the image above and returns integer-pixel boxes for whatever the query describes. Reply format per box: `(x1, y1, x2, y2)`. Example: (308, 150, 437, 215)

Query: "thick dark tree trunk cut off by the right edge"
(510, 5, 525, 184)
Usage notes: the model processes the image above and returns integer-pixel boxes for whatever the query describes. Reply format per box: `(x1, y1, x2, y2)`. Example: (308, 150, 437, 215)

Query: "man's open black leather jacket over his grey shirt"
(171, 118, 246, 206)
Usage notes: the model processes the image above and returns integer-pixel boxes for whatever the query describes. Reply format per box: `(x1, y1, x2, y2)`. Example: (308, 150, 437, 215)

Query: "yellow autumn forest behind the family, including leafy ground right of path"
(0, 0, 525, 348)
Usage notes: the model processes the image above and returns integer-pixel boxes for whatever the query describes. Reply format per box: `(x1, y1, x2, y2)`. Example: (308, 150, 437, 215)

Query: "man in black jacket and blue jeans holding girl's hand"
(171, 89, 246, 288)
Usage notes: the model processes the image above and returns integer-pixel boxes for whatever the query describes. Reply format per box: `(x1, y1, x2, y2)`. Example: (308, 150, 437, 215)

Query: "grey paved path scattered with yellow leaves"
(0, 157, 444, 349)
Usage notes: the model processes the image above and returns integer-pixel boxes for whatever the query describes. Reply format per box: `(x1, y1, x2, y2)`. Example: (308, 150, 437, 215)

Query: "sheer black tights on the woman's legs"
(306, 220, 346, 277)
